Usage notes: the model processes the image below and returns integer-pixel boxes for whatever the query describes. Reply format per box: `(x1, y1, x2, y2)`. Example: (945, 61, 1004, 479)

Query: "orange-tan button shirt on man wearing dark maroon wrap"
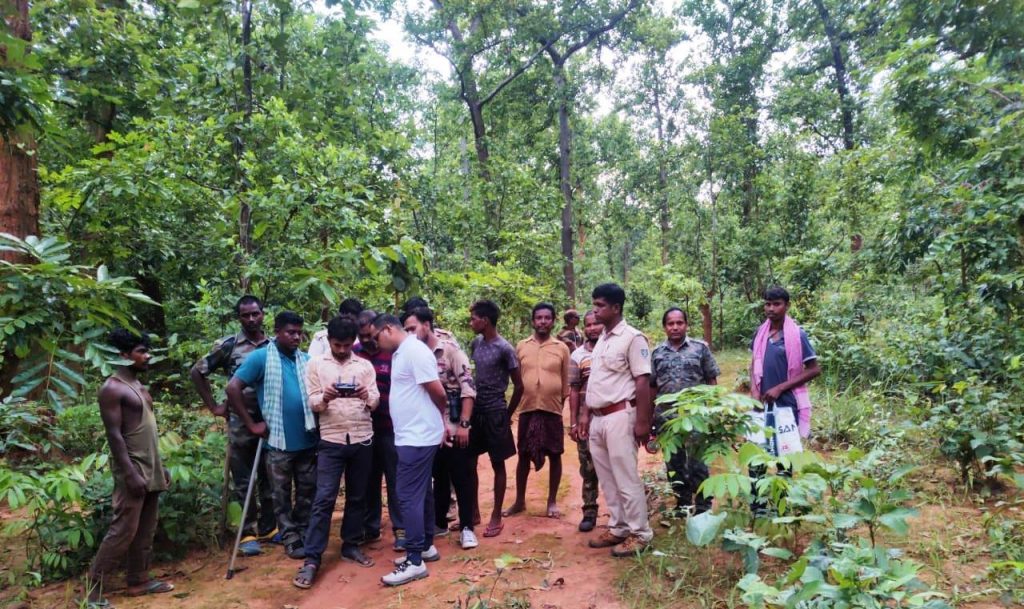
(515, 336, 570, 415)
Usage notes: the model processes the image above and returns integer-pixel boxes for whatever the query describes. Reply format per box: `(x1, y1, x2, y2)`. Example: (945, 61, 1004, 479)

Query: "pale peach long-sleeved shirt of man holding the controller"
(306, 353, 381, 444)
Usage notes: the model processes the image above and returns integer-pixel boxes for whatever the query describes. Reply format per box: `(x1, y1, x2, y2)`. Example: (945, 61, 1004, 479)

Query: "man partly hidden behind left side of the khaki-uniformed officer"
(569, 311, 604, 533)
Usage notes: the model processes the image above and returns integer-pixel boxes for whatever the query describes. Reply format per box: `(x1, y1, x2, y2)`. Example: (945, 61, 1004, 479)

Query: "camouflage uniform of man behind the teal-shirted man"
(196, 332, 278, 536)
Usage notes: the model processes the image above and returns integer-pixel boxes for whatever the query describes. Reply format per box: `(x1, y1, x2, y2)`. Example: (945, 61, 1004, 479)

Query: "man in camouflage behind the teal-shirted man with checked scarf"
(191, 295, 278, 556)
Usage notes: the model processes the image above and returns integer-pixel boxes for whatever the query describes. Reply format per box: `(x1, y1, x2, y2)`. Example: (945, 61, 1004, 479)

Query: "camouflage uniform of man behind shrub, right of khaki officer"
(650, 337, 719, 513)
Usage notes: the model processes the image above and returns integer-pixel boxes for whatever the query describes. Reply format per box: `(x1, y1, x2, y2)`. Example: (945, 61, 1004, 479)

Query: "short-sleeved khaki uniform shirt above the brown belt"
(587, 319, 650, 408)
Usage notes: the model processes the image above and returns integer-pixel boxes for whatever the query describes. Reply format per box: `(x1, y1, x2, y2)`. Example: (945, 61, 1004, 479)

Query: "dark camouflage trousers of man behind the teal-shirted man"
(228, 412, 278, 535)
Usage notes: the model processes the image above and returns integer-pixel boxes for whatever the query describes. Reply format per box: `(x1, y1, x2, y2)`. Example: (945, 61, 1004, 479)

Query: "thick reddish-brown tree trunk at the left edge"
(0, 0, 39, 262)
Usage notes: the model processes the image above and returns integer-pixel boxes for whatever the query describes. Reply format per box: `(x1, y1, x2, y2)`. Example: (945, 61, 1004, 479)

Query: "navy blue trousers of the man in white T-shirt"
(395, 446, 436, 563)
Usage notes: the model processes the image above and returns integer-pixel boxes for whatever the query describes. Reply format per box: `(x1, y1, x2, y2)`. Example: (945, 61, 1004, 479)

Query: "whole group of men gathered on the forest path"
(83, 284, 818, 607)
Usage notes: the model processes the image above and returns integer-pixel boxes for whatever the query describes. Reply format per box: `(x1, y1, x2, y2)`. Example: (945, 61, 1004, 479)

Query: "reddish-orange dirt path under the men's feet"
(46, 411, 657, 609)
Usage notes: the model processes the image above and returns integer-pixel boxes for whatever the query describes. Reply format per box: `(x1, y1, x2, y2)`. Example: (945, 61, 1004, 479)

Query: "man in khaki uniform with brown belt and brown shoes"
(578, 284, 654, 557)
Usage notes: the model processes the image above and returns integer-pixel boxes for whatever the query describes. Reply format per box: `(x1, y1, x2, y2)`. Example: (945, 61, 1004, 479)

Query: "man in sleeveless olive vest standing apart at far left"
(86, 328, 174, 607)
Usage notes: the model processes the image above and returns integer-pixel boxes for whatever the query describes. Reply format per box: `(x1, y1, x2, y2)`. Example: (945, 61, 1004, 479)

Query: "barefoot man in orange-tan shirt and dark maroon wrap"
(504, 302, 569, 518)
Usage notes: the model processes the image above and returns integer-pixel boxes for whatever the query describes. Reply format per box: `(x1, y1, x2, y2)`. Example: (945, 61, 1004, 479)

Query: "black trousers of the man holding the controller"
(305, 440, 373, 565)
